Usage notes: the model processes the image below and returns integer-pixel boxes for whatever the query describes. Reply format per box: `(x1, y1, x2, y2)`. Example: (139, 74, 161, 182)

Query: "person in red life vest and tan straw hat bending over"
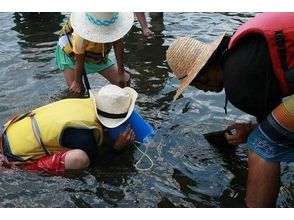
(166, 13, 294, 207)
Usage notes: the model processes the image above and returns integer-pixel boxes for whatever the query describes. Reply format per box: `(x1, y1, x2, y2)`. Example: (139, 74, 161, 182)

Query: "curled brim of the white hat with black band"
(90, 87, 138, 128)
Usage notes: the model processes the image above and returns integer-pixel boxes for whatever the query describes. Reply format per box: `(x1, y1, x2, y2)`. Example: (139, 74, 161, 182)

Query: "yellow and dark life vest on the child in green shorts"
(60, 20, 112, 64)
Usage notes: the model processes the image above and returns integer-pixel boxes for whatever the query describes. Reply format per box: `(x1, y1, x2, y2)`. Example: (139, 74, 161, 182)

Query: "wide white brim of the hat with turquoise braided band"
(70, 12, 134, 43)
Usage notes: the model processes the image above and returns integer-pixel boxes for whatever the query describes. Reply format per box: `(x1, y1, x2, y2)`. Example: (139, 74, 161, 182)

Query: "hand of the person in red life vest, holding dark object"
(225, 123, 254, 145)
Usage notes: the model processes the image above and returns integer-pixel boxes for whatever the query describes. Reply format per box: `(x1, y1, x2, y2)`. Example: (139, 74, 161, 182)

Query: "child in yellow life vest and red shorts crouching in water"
(0, 85, 137, 173)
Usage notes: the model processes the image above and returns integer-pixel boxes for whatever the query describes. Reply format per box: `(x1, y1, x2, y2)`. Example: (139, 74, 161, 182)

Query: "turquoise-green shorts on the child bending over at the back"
(55, 45, 115, 74)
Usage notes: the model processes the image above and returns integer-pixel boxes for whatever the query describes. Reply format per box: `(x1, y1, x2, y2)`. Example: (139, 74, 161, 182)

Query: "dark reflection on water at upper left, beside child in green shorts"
(11, 12, 65, 79)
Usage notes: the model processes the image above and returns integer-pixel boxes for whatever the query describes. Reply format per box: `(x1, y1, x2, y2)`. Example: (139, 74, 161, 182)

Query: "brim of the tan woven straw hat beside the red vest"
(174, 33, 225, 101)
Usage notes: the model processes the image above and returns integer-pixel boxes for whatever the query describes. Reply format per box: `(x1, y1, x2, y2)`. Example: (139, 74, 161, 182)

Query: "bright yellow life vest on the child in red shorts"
(4, 98, 103, 161)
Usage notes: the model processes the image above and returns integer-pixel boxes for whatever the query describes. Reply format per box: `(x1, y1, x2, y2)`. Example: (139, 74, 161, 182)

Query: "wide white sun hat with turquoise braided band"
(70, 12, 134, 43)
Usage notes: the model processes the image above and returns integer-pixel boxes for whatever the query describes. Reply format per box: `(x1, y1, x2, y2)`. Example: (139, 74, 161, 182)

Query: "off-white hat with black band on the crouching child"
(90, 85, 138, 128)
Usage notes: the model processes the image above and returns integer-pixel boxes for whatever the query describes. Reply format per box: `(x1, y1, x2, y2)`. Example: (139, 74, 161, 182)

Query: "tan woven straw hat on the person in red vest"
(166, 33, 225, 100)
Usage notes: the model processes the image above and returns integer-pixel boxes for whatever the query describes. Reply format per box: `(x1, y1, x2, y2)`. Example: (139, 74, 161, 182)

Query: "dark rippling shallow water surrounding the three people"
(0, 13, 294, 207)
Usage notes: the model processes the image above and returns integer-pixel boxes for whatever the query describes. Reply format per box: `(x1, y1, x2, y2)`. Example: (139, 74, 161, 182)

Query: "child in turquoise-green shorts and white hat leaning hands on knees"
(55, 12, 134, 93)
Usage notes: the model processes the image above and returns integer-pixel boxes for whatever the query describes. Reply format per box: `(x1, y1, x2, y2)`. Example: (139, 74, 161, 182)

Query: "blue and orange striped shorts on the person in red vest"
(247, 95, 294, 162)
